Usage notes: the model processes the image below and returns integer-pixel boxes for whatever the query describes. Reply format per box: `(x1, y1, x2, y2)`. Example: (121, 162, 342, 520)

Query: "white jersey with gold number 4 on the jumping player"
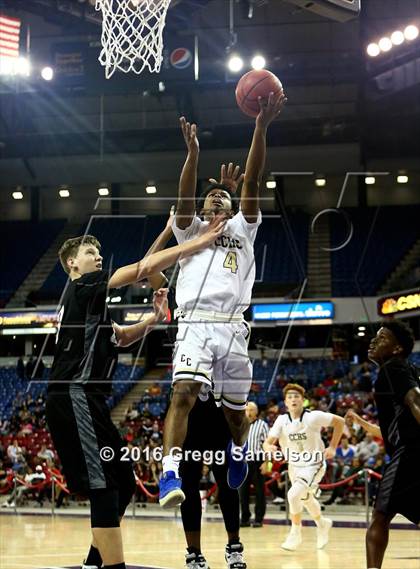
(172, 211, 262, 314)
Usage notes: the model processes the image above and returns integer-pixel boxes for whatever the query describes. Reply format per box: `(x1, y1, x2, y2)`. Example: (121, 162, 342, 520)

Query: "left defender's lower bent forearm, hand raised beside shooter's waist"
(112, 288, 168, 348)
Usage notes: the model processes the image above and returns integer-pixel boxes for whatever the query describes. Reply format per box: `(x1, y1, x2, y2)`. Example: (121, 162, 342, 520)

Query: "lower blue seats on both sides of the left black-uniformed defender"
(0, 364, 144, 420)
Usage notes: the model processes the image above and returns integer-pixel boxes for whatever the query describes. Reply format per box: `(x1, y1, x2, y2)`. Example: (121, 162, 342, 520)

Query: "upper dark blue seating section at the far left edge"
(0, 219, 65, 304)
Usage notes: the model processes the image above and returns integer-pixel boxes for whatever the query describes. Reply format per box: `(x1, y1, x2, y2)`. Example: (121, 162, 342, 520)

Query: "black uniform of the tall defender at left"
(46, 271, 134, 494)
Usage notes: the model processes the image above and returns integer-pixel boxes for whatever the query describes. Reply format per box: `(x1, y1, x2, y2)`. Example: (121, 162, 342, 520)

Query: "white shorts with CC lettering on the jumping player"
(172, 310, 252, 411)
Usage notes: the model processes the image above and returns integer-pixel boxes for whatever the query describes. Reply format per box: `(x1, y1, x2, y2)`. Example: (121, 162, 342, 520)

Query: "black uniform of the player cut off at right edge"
(374, 358, 420, 524)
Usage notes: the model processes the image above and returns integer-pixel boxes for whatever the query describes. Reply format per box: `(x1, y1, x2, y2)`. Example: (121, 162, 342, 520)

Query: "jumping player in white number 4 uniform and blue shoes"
(159, 92, 286, 507)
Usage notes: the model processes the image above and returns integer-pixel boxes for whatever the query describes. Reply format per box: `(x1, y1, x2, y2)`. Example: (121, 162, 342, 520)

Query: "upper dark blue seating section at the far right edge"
(331, 206, 420, 296)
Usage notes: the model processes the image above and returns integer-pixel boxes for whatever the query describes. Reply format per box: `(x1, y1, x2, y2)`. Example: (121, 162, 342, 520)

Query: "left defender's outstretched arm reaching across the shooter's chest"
(108, 215, 226, 288)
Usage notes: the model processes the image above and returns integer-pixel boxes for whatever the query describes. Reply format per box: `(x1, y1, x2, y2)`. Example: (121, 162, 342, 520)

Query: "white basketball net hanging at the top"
(95, 0, 171, 79)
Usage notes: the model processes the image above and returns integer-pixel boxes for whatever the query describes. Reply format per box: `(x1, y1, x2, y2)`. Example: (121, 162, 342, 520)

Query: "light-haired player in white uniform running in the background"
(263, 383, 344, 551)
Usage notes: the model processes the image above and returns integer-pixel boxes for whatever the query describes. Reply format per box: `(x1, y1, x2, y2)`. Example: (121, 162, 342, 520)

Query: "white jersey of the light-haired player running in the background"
(268, 410, 334, 466)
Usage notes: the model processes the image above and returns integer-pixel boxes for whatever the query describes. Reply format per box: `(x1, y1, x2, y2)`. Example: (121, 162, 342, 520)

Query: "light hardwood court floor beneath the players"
(0, 515, 420, 569)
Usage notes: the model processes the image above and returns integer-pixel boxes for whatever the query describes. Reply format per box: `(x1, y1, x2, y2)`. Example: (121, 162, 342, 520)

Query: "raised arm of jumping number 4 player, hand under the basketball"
(241, 91, 287, 223)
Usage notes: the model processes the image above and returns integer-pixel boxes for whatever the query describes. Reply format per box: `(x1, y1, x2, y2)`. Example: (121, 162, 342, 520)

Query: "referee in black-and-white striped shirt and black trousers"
(239, 401, 269, 528)
